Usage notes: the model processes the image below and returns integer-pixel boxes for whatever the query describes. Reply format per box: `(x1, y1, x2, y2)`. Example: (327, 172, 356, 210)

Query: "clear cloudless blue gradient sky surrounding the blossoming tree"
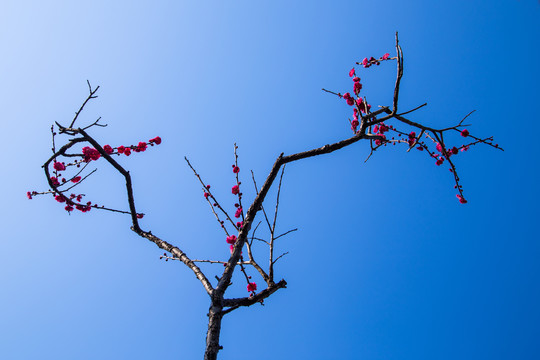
(0, 0, 540, 360)
